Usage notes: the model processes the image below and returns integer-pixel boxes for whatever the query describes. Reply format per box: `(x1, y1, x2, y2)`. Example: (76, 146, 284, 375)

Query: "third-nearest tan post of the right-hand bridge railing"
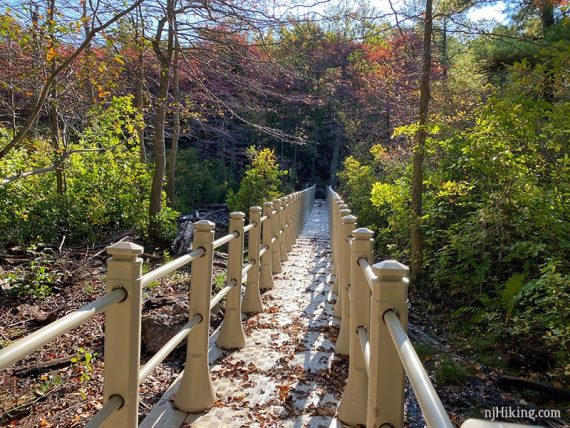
(334, 215, 356, 355)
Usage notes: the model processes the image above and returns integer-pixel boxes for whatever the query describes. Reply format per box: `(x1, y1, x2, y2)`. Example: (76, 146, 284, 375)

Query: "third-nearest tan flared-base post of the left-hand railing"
(216, 211, 245, 349)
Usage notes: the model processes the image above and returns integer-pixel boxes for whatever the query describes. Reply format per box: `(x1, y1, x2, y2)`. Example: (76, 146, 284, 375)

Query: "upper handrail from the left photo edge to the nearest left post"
(0, 288, 127, 369)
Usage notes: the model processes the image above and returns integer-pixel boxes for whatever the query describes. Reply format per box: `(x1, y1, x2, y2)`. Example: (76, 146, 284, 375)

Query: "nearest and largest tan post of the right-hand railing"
(367, 260, 409, 427)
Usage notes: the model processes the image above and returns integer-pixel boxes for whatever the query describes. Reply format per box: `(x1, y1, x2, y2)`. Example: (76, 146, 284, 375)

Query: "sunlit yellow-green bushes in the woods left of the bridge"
(0, 97, 176, 243)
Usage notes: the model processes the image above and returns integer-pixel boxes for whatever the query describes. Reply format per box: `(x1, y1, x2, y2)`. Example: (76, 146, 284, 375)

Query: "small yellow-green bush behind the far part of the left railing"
(227, 146, 287, 214)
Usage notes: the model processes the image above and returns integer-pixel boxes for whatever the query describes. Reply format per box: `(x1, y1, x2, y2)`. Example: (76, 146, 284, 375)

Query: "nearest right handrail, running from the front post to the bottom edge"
(383, 310, 453, 428)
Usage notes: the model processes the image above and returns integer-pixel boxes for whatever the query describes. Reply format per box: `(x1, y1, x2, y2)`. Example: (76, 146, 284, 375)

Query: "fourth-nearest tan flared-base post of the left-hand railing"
(242, 206, 262, 314)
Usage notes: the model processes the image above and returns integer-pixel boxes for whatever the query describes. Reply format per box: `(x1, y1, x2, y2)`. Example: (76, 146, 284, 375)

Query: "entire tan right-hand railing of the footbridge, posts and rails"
(327, 187, 522, 428)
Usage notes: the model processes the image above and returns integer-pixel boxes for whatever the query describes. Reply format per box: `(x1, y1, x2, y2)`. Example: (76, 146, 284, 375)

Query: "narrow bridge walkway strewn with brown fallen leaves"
(141, 201, 348, 428)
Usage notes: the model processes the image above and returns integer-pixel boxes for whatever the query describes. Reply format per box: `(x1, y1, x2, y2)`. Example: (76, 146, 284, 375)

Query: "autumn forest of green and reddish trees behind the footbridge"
(0, 0, 570, 400)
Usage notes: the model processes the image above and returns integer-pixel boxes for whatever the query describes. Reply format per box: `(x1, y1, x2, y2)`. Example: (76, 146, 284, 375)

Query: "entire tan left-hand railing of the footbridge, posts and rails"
(0, 186, 315, 427)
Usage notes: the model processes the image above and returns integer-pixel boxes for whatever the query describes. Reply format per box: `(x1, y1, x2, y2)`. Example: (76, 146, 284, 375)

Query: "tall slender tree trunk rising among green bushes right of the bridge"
(411, 0, 433, 279)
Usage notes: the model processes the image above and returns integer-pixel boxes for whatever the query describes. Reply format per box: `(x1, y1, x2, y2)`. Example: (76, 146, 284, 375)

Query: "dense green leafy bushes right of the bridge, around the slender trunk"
(339, 41, 570, 378)
